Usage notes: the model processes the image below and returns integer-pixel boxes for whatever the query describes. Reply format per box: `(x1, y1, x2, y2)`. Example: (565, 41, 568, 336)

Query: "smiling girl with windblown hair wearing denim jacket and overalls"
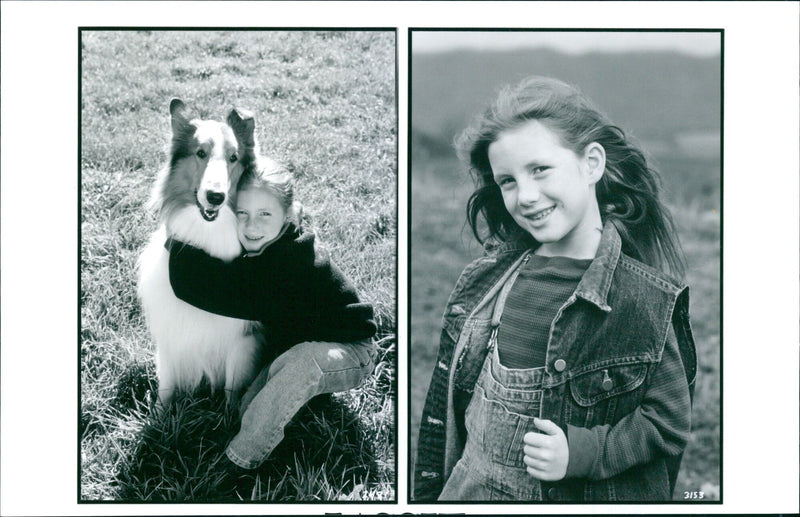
(414, 77, 696, 502)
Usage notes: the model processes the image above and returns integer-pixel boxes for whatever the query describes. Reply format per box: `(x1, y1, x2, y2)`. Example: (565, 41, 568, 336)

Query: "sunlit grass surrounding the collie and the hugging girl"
(79, 31, 397, 502)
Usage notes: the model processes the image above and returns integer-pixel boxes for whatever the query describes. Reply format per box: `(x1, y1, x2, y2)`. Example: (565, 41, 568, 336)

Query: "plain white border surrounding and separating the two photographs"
(0, 2, 800, 515)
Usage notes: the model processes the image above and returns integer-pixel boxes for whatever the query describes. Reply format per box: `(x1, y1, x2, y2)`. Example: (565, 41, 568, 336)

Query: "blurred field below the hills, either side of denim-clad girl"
(409, 143, 721, 500)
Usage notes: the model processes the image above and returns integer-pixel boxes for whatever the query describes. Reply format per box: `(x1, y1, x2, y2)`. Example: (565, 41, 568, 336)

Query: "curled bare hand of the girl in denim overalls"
(522, 418, 569, 481)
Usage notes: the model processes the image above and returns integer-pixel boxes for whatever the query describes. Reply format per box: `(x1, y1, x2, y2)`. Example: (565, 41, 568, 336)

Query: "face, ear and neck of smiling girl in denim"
(488, 120, 605, 258)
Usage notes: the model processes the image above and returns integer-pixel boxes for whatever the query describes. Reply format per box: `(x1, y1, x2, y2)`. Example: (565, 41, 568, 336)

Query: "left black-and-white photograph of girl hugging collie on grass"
(78, 28, 397, 503)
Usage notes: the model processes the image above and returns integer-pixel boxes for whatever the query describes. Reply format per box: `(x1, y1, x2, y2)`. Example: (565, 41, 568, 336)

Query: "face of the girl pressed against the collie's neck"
(236, 188, 286, 252)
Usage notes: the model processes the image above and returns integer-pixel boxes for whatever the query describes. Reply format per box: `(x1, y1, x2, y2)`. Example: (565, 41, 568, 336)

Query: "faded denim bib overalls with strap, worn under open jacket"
(439, 254, 545, 501)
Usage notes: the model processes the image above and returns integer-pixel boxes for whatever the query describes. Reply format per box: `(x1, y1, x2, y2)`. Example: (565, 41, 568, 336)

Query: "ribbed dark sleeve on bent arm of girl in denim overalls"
(566, 330, 691, 479)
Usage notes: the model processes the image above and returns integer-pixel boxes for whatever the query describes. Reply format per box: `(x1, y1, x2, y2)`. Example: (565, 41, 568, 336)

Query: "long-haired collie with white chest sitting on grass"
(138, 99, 263, 405)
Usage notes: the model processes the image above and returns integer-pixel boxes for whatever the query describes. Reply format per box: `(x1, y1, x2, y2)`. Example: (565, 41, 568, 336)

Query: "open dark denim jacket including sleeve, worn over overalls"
(414, 223, 697, 502)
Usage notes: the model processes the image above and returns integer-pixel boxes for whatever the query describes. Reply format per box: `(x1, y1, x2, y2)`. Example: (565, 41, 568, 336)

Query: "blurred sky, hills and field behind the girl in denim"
(409, 31, 722, 500)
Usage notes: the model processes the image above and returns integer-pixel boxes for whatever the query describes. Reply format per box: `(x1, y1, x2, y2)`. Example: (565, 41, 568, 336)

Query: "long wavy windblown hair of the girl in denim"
(455, 76, 685, 278)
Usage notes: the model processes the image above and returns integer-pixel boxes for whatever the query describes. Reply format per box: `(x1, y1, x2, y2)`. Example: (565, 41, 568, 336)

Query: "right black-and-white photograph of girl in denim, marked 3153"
(408, 29, 724, 504)
